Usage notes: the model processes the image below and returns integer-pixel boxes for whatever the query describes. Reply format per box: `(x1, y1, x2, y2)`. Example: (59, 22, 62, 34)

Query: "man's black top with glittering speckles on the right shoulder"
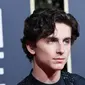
(17, 72, 85, 85)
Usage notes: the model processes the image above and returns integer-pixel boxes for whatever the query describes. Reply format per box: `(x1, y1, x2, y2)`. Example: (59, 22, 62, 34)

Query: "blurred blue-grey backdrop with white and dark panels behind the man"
(0, 0, 85, 85)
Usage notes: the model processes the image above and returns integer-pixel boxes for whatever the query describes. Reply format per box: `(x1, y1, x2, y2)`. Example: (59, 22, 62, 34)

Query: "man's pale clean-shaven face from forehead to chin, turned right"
(34, 23, 71, 70)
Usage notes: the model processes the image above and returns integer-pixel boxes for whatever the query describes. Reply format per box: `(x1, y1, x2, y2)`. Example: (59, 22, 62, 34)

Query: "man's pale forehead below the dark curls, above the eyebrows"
(50, 23, 71, 38)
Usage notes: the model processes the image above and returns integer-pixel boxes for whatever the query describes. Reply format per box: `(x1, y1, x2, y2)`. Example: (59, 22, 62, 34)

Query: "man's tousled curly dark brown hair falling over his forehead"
(21, 8, 79, 61)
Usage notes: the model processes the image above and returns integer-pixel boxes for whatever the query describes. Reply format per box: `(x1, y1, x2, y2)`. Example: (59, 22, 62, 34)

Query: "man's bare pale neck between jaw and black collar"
(32, 62, 61, 84)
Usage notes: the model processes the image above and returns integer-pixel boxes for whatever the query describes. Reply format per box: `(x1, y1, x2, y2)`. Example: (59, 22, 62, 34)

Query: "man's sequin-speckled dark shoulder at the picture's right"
(62, 72, 85, 85)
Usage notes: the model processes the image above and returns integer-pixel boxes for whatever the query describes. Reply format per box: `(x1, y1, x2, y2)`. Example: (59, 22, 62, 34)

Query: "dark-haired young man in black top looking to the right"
(18, 8, 85, 85)
